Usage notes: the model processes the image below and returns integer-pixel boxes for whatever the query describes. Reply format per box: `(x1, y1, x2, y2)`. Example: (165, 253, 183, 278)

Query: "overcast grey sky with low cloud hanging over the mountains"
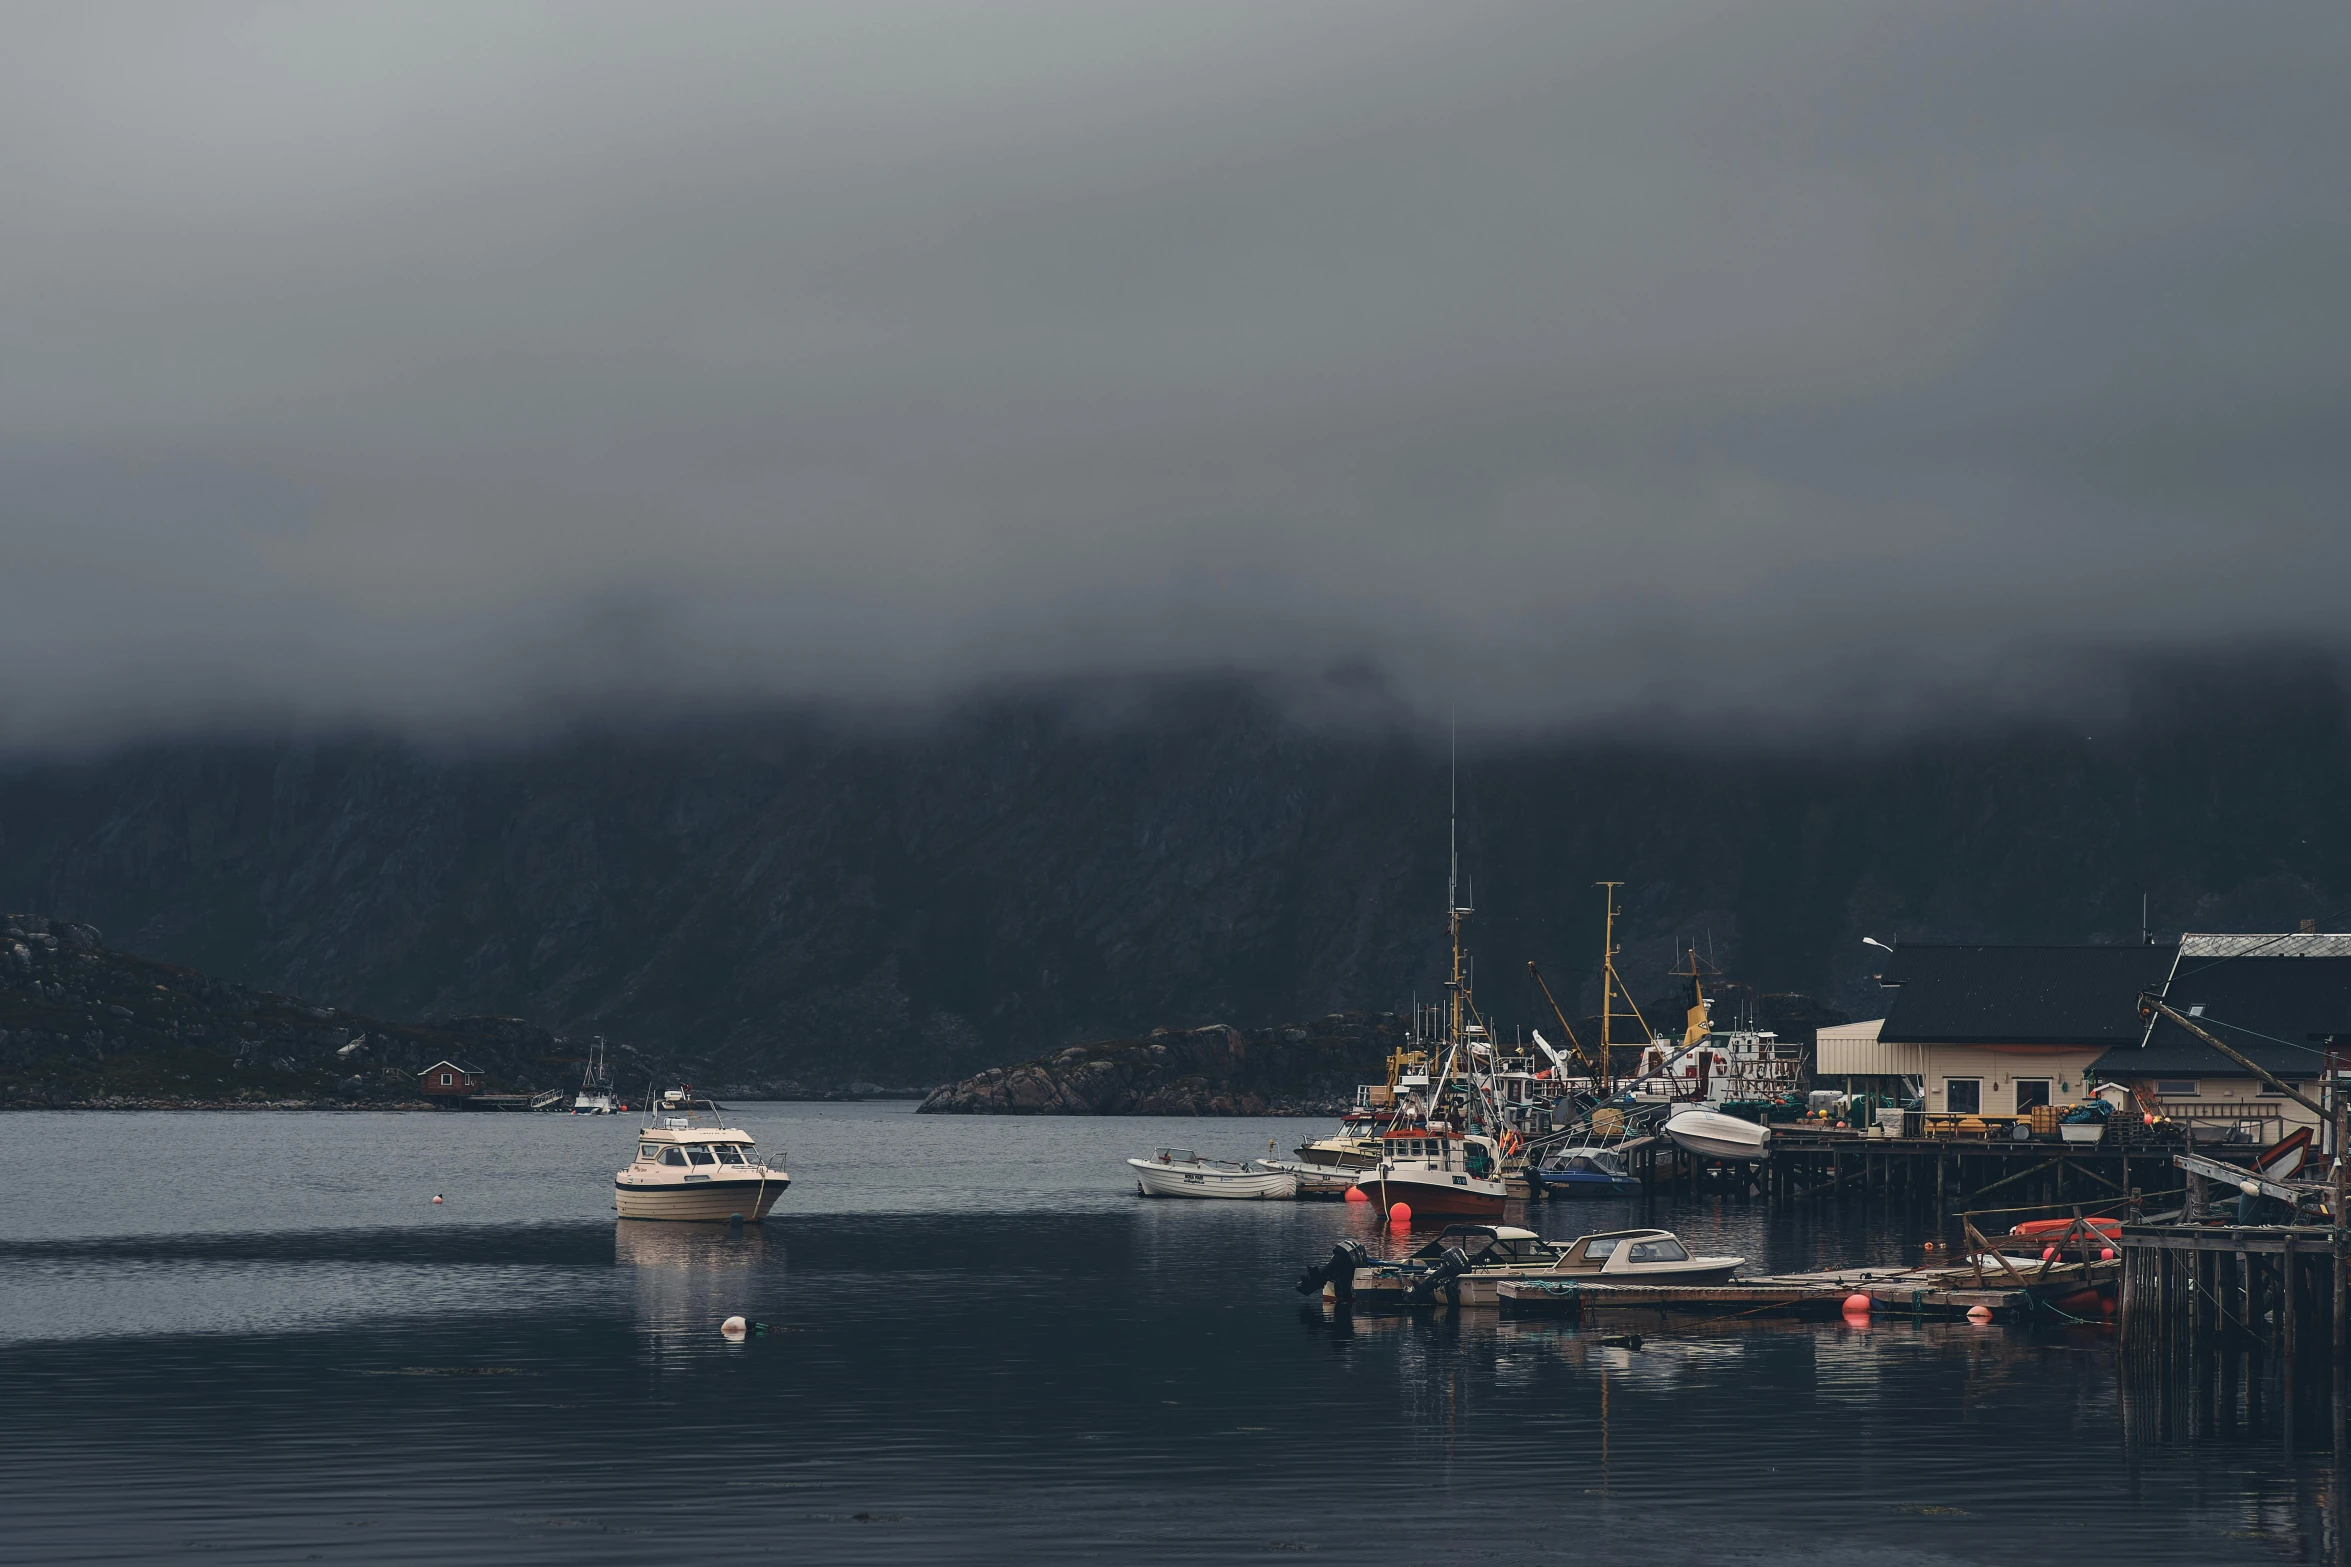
(0, 0, 2351, 747)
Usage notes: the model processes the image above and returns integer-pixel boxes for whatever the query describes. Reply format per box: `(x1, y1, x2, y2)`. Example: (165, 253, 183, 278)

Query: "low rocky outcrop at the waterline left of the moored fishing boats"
(919, 1013, 1404, 1116)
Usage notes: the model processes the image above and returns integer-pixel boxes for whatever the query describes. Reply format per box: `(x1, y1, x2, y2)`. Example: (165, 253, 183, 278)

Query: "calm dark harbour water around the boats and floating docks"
(0, 1104, 2339, 1567)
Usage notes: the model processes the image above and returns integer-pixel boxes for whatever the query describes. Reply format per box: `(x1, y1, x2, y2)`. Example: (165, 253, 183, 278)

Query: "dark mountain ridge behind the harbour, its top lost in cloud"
(0, 665, 2351, 1085)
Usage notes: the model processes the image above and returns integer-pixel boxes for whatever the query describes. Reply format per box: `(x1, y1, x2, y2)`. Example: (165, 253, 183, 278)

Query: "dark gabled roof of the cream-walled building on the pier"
(1878, 942, 2175, 1045)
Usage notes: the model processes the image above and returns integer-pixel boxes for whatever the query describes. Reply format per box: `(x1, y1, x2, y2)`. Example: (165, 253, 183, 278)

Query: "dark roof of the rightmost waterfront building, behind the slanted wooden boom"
(2095, 949, 2351, 1078)
